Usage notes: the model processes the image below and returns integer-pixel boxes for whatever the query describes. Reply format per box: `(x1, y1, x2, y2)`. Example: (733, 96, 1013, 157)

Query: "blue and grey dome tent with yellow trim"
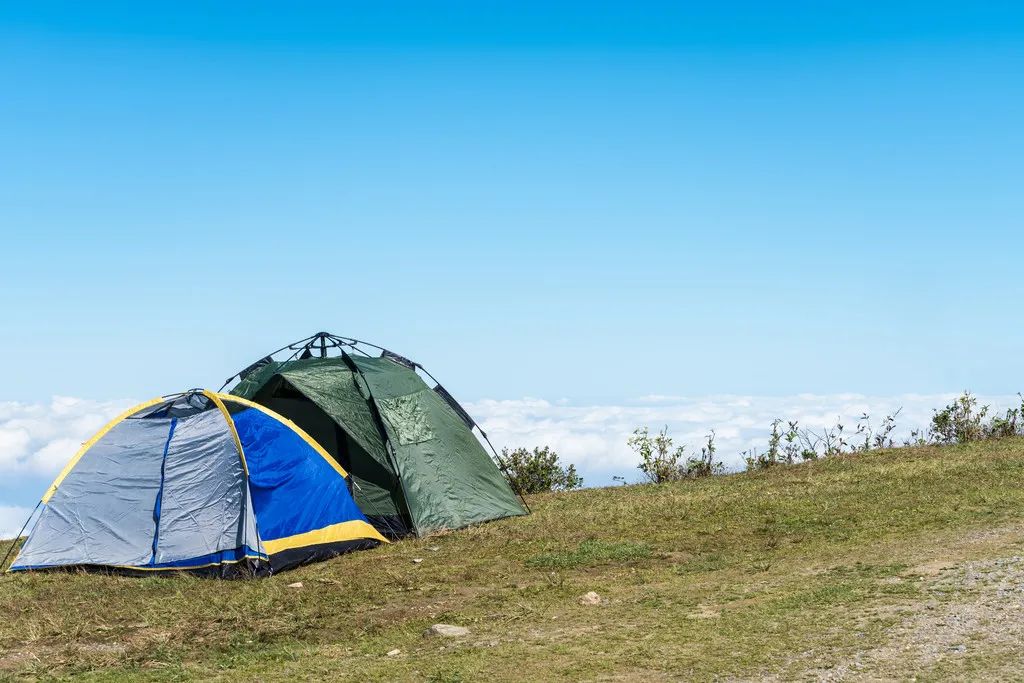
(10, 389, 386, 577)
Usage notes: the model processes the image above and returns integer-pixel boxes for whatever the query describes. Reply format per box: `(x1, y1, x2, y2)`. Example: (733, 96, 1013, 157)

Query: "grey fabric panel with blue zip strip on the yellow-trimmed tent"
(17, 401, 260, 568)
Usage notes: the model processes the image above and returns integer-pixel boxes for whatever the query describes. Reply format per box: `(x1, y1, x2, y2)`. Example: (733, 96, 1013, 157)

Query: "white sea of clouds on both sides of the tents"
(0, 393, 1019, 538)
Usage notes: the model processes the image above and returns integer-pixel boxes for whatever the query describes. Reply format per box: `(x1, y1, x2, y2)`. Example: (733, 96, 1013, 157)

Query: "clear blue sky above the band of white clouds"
(0, 2, 1024, 524)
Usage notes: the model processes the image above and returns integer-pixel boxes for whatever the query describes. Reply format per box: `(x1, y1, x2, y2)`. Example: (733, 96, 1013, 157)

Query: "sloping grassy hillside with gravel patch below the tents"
(0, 439, 1024, 683)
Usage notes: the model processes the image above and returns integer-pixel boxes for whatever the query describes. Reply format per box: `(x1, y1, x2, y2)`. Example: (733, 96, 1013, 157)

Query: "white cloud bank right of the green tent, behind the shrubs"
(467, 393, 1020, 484)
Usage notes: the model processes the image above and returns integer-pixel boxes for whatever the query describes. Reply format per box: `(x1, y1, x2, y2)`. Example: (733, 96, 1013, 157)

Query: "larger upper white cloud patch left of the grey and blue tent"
(0, 396, 132, 475)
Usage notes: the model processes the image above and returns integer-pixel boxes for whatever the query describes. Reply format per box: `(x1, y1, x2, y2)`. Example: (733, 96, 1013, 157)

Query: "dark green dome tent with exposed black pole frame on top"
(222, 332, 528, 538)
